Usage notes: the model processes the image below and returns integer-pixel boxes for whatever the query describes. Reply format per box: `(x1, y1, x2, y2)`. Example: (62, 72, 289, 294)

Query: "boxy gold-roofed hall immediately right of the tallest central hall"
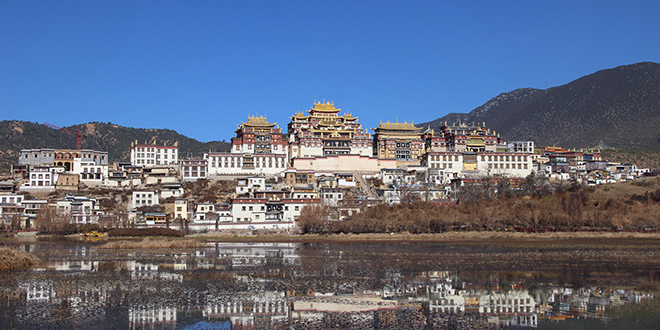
(374, 120, 425, 162)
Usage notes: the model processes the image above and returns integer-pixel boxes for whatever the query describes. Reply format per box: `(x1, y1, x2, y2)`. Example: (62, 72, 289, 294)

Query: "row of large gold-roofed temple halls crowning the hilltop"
(179, 102, 533, 180)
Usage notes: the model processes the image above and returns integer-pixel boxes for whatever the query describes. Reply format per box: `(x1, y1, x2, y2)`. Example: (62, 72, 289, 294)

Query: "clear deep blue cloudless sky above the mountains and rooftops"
(0, 0, 660, 142)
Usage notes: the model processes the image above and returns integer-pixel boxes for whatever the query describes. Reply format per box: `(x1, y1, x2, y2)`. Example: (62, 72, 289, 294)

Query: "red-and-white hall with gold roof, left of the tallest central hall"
(204, 116, 288, 176)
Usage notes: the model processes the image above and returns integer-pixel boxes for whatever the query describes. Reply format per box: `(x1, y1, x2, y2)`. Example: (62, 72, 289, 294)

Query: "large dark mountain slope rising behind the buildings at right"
(418, 62, 660, 150)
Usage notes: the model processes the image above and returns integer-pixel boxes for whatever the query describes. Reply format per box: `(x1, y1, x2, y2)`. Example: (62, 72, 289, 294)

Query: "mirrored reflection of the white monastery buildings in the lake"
(8, 243, 652, 329)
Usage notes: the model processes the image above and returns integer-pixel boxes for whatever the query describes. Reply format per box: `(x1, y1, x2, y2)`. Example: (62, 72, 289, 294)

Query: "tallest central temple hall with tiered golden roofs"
(288, 102, 373, 158)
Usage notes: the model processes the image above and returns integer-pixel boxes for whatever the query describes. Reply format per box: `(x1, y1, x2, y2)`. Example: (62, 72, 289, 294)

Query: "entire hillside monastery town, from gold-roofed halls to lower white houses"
(5, 102, 640, 231)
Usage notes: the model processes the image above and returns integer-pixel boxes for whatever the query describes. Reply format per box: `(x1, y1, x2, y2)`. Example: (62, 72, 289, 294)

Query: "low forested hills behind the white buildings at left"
(0, 120, 231, 172)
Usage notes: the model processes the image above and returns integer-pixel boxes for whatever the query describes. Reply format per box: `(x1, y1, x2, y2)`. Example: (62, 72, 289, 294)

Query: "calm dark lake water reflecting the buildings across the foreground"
(0, 237, 660, 330)
